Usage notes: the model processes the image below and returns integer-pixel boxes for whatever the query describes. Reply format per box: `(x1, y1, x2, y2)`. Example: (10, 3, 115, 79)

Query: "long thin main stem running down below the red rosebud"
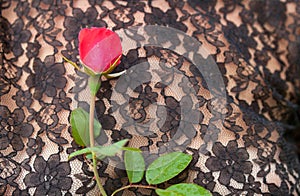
(89, 82, 107, 196)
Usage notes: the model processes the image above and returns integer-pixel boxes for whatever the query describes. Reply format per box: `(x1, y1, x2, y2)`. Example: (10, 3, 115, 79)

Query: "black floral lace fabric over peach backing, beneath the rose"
(0, 0, 300, 196)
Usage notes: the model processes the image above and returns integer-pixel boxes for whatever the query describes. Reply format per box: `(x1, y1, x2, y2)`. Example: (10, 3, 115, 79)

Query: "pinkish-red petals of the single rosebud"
(78, 27, 122, 74)
